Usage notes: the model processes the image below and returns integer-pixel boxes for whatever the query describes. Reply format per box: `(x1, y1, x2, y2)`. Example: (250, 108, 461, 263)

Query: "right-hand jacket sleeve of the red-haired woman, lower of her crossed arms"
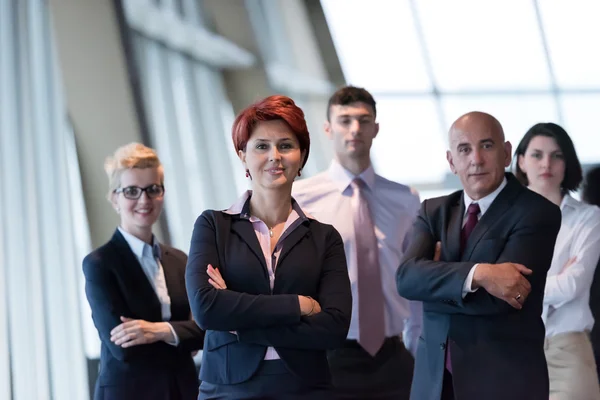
(237, 228, 352, 349)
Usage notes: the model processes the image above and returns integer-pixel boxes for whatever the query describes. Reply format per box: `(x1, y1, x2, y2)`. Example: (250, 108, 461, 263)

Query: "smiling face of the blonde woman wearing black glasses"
(112, 168, 164, 237)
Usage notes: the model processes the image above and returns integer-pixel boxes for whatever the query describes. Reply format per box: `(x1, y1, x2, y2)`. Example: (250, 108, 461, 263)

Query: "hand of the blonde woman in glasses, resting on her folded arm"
(110, 317, 175, 348)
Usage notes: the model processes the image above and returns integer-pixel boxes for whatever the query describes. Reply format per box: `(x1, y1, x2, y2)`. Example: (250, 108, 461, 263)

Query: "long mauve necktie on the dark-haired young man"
(351, 178, 385, 356)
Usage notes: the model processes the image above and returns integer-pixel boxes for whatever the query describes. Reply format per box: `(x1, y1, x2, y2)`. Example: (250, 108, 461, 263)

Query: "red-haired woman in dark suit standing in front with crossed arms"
(186, 96, 352, 399)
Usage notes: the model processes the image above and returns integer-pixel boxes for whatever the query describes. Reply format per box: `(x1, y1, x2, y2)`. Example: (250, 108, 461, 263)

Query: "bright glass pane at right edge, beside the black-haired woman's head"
(561, 94, 600, 164)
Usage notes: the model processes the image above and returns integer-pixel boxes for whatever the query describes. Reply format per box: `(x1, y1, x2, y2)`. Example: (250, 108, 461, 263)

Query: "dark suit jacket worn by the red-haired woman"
(186, 201, 352, 385)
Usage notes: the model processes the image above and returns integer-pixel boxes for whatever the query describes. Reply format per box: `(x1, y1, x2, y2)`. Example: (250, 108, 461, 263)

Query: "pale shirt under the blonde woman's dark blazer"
(119, 227, 179, 346)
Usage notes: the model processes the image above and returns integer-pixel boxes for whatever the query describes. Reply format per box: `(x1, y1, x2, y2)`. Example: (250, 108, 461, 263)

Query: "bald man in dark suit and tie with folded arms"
(396, 112, 561, 400)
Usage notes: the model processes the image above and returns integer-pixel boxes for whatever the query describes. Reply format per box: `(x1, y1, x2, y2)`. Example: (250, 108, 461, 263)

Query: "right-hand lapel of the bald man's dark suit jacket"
(462, 174, 523, 261)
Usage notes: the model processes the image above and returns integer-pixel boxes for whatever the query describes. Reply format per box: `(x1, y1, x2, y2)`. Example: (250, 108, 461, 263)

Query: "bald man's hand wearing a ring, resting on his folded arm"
(472, 263, 533, 310)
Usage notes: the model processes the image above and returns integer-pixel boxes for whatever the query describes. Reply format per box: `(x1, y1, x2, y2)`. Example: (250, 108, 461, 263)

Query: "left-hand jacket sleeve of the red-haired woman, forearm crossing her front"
(185, 211, 300, 331)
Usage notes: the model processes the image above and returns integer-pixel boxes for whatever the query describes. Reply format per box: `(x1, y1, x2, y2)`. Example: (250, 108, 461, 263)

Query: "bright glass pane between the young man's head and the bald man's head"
(372, 97, 449, 185)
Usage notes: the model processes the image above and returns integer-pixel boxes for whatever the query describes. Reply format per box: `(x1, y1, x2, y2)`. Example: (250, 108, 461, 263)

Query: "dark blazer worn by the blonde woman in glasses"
(83, 229, 204, 400)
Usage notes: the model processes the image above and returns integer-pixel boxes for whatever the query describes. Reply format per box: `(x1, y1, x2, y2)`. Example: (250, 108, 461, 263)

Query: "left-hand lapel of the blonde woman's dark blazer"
(111, 229, 162, 321)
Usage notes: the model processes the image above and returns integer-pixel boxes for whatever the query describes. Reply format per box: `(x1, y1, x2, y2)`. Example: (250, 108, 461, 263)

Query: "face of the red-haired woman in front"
(239, 120, 304, 190)
